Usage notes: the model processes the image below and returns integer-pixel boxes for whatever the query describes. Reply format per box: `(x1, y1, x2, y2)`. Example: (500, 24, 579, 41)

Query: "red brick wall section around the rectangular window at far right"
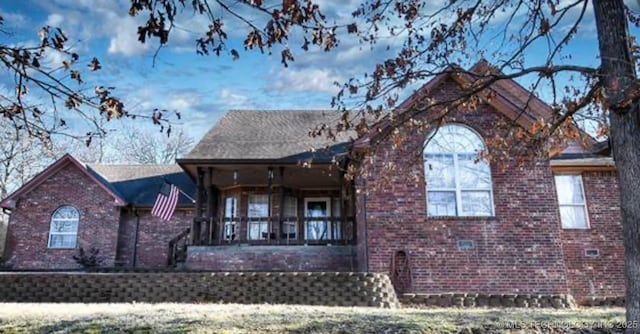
(562, 172, 624, 299)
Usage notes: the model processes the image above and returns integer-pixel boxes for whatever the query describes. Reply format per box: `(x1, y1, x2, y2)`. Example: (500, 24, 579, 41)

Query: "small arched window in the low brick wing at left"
(49, 206, 80, 248)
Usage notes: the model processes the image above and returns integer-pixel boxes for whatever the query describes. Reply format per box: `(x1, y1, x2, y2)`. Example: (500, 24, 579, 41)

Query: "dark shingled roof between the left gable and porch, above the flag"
(87, 164, 195, 207)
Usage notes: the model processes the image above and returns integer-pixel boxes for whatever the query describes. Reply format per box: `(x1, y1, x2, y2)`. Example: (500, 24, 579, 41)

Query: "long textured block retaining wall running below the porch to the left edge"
(0, 272, 398, 307)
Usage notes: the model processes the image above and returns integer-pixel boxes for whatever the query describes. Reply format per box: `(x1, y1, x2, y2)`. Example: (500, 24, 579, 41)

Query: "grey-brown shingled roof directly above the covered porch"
(181, 110, 355, 161)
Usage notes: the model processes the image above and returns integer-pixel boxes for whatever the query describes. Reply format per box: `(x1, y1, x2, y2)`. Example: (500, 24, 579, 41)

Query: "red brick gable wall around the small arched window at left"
(4, 165, 120, 269)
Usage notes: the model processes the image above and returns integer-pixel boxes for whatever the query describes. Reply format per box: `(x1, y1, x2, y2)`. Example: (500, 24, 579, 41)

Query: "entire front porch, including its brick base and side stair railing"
(169, 162, 357, 271)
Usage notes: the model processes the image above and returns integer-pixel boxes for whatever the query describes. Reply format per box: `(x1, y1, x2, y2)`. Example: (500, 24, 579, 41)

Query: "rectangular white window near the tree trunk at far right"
(555, 175, 589, 229)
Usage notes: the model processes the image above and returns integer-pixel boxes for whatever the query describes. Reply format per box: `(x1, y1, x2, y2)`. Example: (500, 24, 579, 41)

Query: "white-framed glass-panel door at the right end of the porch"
(304, 197, 331, 240)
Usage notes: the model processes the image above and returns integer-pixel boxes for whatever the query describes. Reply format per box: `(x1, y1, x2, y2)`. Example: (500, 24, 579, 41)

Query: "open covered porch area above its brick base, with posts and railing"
(181, 161, 356, 246)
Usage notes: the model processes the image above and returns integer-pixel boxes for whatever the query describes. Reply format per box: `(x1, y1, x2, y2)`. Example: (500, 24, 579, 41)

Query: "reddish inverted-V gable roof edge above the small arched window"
(0, 153, 126, 209)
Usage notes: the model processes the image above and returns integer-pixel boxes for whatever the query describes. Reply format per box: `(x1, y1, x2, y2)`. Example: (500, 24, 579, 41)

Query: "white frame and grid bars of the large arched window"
(422, 123, 495, 217)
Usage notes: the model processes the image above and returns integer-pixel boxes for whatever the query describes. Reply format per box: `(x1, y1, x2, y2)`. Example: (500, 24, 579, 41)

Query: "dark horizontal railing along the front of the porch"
(192, 216, 355, 245)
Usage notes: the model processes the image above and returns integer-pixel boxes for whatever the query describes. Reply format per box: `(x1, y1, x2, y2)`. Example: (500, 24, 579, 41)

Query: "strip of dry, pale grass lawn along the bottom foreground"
(0, 303, 624, 334)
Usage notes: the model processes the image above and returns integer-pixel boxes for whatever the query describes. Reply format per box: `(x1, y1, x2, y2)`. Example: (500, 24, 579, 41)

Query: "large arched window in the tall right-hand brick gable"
(424, 124, 493, 216)
